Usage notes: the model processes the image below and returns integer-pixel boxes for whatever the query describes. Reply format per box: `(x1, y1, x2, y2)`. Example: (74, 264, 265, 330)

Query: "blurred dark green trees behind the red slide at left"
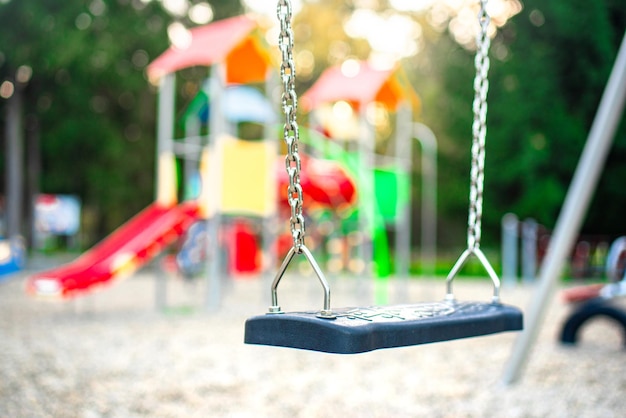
(0, 0, 241, 243)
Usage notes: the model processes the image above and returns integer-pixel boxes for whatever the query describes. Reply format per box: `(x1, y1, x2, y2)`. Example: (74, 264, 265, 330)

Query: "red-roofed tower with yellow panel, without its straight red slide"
(148, 16, 355, 306)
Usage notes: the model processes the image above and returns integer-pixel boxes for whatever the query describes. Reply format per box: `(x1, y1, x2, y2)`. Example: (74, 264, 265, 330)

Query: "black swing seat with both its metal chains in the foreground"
(244, 0, 523, 354)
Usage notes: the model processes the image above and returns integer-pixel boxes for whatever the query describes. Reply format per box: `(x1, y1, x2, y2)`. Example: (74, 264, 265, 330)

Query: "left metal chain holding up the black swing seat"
(277, 0, 306, 253)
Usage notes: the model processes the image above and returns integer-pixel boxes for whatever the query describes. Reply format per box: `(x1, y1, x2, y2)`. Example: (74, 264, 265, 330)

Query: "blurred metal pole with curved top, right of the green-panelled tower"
(413, 123, 437, 276)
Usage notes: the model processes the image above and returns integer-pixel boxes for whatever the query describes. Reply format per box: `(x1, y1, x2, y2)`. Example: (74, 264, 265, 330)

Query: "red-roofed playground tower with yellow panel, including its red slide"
(27, 16, 356, 300)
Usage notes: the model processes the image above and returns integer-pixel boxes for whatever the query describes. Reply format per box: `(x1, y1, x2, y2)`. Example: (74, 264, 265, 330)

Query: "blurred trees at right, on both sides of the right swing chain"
(408, 0, 626, 245)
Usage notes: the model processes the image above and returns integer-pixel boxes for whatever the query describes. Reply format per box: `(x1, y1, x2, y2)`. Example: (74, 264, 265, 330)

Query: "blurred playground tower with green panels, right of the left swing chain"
(302, 60, 419, 277)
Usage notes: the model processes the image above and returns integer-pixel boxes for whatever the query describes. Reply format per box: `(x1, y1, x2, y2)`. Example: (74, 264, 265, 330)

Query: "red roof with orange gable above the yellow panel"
(148, 16, 270, 83)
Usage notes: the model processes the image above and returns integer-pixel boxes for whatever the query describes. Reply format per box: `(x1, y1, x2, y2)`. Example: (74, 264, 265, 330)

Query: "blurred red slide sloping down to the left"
(26, 201, 198, 298)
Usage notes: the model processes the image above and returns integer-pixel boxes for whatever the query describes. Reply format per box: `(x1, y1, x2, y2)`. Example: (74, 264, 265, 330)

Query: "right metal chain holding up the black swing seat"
(467, 0, 491, 250)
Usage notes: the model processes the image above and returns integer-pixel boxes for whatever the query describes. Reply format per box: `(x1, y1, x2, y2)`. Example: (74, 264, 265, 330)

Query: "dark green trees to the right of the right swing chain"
(486, 0, 626, 235)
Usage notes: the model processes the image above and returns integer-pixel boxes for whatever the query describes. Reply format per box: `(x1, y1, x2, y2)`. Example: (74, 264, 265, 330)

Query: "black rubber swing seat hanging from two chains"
(244, 301, 523, 354)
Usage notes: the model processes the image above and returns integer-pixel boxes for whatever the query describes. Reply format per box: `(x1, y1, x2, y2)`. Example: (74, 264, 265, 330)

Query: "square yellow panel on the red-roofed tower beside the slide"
(217, 137, 276, 216)
